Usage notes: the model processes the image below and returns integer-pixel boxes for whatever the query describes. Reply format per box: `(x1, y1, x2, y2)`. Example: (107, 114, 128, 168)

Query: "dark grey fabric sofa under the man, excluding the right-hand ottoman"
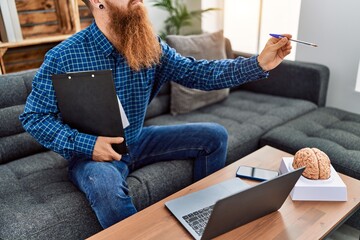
(0, 44, 358, 239)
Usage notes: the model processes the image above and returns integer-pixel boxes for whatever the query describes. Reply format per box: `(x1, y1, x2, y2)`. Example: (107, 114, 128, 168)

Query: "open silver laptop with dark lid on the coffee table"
(165, 168, 305, 239)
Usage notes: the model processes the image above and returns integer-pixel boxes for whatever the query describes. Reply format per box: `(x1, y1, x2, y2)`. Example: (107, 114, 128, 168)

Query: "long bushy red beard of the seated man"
(108, 1, 162, 71)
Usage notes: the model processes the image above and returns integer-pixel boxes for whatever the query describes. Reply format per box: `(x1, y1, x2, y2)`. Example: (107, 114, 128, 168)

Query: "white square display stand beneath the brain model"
(280, 157, 347, 201)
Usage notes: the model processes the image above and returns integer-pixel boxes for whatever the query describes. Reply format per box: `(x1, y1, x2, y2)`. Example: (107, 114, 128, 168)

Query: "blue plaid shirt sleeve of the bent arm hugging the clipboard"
(20, 51, 96, 159)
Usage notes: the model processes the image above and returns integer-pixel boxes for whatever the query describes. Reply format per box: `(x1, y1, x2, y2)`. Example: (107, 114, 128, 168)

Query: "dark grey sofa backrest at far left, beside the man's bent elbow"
(0, 69, 45, 164)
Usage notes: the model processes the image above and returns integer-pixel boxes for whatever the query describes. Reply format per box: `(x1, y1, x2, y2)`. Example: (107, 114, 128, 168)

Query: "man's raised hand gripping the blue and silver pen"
(258, 34, 292, 71)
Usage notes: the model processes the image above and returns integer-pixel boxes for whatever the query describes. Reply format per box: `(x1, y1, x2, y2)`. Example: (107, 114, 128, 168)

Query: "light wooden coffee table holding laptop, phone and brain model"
(89, 146, 360, 240)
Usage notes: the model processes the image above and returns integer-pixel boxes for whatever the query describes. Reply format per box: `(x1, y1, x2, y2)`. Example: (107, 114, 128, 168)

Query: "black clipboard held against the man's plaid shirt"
(52, 70, 128, 154)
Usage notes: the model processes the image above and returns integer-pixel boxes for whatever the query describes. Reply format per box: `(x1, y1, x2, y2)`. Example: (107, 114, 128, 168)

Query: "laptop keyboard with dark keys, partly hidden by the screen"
(183, 205, 214, 236)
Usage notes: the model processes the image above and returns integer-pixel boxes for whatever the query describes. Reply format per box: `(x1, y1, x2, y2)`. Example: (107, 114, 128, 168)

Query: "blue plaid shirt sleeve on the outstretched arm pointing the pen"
(159, 42, 269, 90)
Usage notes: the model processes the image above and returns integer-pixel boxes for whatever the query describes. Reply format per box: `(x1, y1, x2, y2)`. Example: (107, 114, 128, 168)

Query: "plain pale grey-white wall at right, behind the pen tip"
(296, 0, 360, 113)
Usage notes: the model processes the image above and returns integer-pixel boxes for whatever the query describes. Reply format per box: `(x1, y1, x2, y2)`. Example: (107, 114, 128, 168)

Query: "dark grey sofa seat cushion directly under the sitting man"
(0, 151, 192, 240)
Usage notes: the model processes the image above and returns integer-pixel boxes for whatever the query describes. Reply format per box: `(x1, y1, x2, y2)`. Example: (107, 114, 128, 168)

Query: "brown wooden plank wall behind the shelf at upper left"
(0, 0, 93, 74)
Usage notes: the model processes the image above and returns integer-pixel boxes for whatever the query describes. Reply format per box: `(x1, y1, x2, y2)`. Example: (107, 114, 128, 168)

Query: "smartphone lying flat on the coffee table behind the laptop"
(236, 166, 279, 181)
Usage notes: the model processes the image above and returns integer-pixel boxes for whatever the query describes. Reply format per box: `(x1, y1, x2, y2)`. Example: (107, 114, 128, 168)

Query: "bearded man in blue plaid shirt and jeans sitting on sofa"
(20, 0, 291, 228)
